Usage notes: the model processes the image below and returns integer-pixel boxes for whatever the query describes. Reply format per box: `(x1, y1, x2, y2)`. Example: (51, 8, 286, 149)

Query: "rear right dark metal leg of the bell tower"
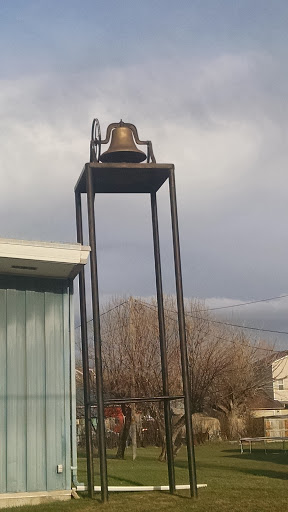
(151, 192, 175, 494)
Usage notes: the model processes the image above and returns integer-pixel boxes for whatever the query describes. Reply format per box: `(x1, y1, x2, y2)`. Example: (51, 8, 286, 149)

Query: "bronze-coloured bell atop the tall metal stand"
(99, 126, 147, 164)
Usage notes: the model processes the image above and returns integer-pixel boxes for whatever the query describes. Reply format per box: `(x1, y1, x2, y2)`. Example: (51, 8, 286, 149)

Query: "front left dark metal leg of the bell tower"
(87, 167, 108, 502)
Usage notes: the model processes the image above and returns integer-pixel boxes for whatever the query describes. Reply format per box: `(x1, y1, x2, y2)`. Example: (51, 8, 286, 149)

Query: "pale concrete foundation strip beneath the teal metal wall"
(0, 489, 71, 508)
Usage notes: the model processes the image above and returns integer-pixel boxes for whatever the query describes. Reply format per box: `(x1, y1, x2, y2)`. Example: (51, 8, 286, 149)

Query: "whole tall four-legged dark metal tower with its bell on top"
(75, 119, 197, 501)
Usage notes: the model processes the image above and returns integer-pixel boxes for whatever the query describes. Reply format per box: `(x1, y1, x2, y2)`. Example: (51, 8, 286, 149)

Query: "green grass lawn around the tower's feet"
(4, 443, 288, 512)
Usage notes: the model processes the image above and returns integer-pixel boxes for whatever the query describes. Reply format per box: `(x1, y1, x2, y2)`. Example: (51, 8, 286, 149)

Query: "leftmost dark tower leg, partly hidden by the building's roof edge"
(75, 194, 94, 498)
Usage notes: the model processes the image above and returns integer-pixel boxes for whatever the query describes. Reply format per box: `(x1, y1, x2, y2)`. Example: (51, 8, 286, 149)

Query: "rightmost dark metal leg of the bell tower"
(169, 169, 197, 497)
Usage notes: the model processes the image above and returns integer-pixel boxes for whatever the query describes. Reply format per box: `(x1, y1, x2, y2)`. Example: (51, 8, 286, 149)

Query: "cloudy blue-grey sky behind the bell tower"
(0, 0, 288, 348)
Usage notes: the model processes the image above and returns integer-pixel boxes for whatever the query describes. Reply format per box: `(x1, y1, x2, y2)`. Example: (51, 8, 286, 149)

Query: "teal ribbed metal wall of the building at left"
(0, 276, 71, 493)
